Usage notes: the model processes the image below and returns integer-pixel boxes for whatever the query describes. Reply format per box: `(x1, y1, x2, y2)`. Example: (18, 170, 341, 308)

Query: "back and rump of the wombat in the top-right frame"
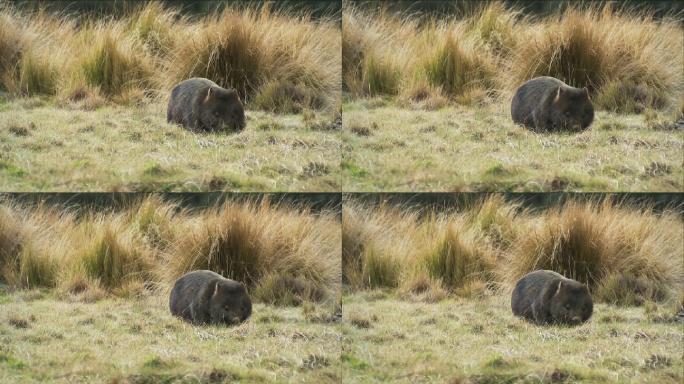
(511, 76, 568, 128)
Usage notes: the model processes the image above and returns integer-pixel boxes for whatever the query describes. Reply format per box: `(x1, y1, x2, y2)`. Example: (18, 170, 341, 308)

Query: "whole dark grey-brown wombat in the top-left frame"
(166, 77, 245, 131)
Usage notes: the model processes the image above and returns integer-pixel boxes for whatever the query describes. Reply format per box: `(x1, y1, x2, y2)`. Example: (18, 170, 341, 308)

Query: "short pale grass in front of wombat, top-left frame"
(0, 99, 340, 191)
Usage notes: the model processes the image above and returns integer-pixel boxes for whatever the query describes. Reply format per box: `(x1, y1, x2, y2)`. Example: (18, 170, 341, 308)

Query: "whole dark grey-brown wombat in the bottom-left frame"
(169, 270, 252, 325)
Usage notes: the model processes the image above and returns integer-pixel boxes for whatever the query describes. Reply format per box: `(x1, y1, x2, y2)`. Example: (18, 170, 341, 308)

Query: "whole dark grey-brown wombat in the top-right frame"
(511, 77, 594, 131)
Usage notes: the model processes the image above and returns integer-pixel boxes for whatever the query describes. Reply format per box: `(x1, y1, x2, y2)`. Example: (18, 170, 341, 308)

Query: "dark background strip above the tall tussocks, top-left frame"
(13, 0, 342, 18)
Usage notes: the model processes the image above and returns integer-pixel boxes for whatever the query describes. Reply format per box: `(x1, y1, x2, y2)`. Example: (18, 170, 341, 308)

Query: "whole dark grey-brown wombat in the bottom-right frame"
(511, 270, 594, 325)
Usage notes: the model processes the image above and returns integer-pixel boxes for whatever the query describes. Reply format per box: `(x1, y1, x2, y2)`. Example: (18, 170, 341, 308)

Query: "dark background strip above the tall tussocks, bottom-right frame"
(343, 192, 684, 217)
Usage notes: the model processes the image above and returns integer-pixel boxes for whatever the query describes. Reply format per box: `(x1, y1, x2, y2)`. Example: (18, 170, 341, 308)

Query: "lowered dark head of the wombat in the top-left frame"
(199, 86, 246, 131)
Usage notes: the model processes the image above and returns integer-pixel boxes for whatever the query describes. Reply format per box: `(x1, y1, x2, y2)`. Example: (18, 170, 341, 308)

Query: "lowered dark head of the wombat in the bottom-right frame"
(551, 280, 594, 325)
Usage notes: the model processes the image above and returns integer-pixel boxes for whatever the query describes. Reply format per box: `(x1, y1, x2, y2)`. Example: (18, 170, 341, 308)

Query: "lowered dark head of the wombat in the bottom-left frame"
(209, 280, 252, 325)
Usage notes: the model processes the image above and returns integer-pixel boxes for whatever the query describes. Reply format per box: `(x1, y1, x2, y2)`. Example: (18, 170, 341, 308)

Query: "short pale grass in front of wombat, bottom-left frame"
(0, 290, 340, 383)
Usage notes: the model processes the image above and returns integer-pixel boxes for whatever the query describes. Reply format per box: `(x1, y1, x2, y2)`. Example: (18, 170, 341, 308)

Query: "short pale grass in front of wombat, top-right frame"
(342, 99, 684, 191)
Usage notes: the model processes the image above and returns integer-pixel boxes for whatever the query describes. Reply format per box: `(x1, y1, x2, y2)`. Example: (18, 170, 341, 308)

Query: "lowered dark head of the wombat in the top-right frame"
(548, 86, 594, 131)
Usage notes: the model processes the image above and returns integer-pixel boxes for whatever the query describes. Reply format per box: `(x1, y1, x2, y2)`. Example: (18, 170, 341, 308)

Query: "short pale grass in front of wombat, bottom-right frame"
(342, 291, 684, 383)
